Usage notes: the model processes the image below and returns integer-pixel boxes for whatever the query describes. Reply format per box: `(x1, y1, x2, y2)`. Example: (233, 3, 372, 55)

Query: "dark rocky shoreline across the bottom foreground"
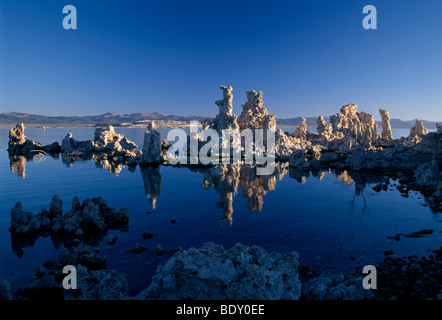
(0, 243, 442, 301)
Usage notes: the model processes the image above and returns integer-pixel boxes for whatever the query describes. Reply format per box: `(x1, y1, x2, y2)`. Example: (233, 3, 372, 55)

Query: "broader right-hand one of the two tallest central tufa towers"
(238, 90, 276, 130)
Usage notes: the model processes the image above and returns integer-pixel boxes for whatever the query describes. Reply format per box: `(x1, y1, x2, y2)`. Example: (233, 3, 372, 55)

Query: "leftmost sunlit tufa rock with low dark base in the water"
(8, 122, 60, 156)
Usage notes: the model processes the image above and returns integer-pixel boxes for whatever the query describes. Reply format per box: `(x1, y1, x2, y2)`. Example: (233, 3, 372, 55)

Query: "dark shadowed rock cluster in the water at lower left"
(9, 195, 129, 256)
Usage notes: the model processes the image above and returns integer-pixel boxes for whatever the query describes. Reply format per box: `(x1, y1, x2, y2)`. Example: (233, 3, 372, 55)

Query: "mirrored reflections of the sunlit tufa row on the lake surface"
(9, 153, 422, 224)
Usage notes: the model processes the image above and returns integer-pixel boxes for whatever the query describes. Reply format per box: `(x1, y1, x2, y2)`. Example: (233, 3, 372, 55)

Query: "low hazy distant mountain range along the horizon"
(0, 112, 436, 129)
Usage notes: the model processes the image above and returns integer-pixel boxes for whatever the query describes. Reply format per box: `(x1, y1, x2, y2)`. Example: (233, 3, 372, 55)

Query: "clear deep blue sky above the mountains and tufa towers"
(0, 0, 442, 121)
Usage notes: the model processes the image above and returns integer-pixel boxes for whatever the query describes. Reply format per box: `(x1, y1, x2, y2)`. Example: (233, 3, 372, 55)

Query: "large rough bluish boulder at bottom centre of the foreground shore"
(137, 243, 301, 300)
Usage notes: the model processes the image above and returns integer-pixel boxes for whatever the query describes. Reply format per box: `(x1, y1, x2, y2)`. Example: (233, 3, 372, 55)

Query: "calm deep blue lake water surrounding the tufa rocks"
(0, 128, 442, 294)
